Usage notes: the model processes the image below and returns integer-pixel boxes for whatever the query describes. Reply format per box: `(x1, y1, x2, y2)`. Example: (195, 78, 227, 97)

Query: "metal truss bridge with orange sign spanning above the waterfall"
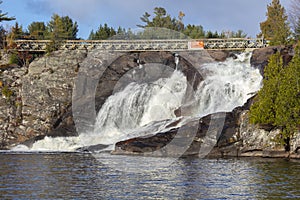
(14, 38, 267, 52)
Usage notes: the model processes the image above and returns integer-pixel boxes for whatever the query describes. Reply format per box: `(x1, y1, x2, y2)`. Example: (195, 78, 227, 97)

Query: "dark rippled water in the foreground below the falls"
(0, 153, 300, 199)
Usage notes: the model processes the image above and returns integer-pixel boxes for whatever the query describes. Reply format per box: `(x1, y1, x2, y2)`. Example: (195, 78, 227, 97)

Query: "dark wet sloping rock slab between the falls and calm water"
(113, 113, 236, 157)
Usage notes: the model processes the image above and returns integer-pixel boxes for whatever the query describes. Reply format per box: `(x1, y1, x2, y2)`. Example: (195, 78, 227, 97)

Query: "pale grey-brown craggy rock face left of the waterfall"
(0, 51, 86, 149)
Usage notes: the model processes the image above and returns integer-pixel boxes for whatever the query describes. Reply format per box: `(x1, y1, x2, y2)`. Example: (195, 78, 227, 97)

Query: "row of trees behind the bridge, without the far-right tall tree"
(2, 7, 247, 40)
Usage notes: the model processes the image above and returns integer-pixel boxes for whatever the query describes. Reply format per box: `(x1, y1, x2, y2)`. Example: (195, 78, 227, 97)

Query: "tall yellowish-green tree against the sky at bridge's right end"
(260, 0, 291, 45)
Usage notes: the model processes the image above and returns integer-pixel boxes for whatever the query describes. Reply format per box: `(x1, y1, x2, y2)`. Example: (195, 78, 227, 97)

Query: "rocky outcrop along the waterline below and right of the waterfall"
(113, 96, 300, 158)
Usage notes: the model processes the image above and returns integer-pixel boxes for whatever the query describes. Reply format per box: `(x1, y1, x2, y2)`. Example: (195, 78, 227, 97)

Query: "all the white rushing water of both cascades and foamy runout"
(15, 53, 262, 151)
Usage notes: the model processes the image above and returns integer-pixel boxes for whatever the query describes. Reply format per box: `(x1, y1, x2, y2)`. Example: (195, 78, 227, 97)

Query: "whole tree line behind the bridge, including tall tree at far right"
(0, 0, 300, 44)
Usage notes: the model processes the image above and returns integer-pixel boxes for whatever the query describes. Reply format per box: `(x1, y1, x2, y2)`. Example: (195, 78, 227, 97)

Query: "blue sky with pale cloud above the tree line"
(0, 0, 289, 39)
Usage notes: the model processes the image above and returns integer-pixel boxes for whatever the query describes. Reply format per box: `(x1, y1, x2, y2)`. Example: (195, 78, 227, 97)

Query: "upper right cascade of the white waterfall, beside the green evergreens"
(194, 53, 262, 116)
